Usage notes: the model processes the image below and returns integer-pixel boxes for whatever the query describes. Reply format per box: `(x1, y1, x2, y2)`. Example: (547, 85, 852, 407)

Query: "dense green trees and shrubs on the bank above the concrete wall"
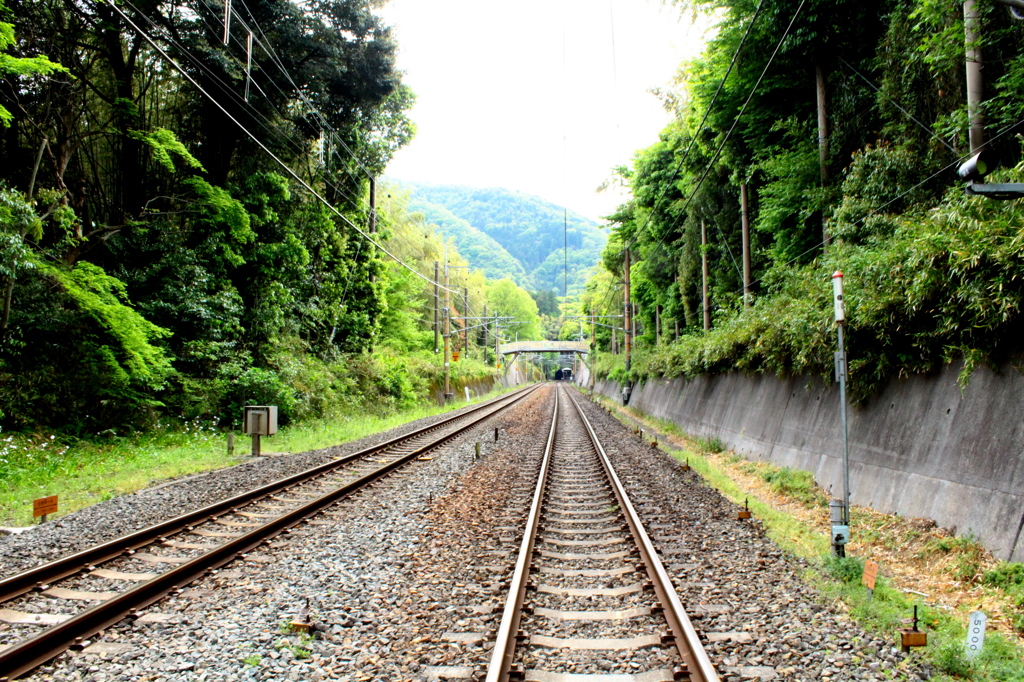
(587, 0, 1024, 397)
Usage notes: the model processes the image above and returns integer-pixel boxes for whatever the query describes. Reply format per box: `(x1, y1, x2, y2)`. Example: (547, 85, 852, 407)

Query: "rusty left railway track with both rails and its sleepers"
(0, 386, 536, 682)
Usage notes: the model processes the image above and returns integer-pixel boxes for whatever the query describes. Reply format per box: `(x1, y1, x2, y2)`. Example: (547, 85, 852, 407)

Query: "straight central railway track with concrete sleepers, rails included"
(486, 387, 719, 682)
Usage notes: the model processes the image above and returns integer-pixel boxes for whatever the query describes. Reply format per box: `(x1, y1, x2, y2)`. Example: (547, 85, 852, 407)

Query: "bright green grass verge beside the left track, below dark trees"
(0, 382, 506, 526)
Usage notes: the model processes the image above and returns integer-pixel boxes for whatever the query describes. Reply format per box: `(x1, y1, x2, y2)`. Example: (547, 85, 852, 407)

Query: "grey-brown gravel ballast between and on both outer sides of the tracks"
(0, 389, 926, 682)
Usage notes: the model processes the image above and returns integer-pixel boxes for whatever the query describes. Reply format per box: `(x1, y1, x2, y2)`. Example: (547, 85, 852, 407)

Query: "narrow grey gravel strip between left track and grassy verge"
(0, 395, 505, 578)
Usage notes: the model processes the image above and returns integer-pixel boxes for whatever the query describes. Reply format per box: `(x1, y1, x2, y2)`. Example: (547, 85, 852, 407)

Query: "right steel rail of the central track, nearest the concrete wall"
(568, 387, 719, 682)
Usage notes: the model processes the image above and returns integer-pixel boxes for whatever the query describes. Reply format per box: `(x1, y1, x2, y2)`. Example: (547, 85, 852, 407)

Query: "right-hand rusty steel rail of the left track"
(0, 386, 537, 682)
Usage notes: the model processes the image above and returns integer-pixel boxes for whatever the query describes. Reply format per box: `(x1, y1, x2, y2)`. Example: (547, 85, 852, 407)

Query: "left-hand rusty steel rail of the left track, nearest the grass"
(0, 388, 529, 604)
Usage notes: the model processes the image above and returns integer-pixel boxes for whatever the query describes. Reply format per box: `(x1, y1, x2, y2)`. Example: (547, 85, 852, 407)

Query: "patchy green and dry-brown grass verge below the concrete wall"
(592, 393, 1024, 682)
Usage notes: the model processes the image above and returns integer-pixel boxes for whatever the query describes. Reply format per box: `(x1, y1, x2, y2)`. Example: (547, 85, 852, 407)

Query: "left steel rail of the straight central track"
(485, 382, 560, 682)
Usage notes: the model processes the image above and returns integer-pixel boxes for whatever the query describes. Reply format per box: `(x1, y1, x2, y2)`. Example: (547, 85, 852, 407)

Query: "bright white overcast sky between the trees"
(380, 0, 703, 220)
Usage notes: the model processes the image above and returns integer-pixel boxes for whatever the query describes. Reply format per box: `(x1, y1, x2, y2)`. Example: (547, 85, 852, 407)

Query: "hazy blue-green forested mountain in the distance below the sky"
(394, 180, 607, 295)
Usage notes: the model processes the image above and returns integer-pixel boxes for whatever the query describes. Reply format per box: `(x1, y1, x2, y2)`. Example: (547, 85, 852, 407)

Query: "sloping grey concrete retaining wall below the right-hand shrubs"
(594, 366, 1024, 561)
